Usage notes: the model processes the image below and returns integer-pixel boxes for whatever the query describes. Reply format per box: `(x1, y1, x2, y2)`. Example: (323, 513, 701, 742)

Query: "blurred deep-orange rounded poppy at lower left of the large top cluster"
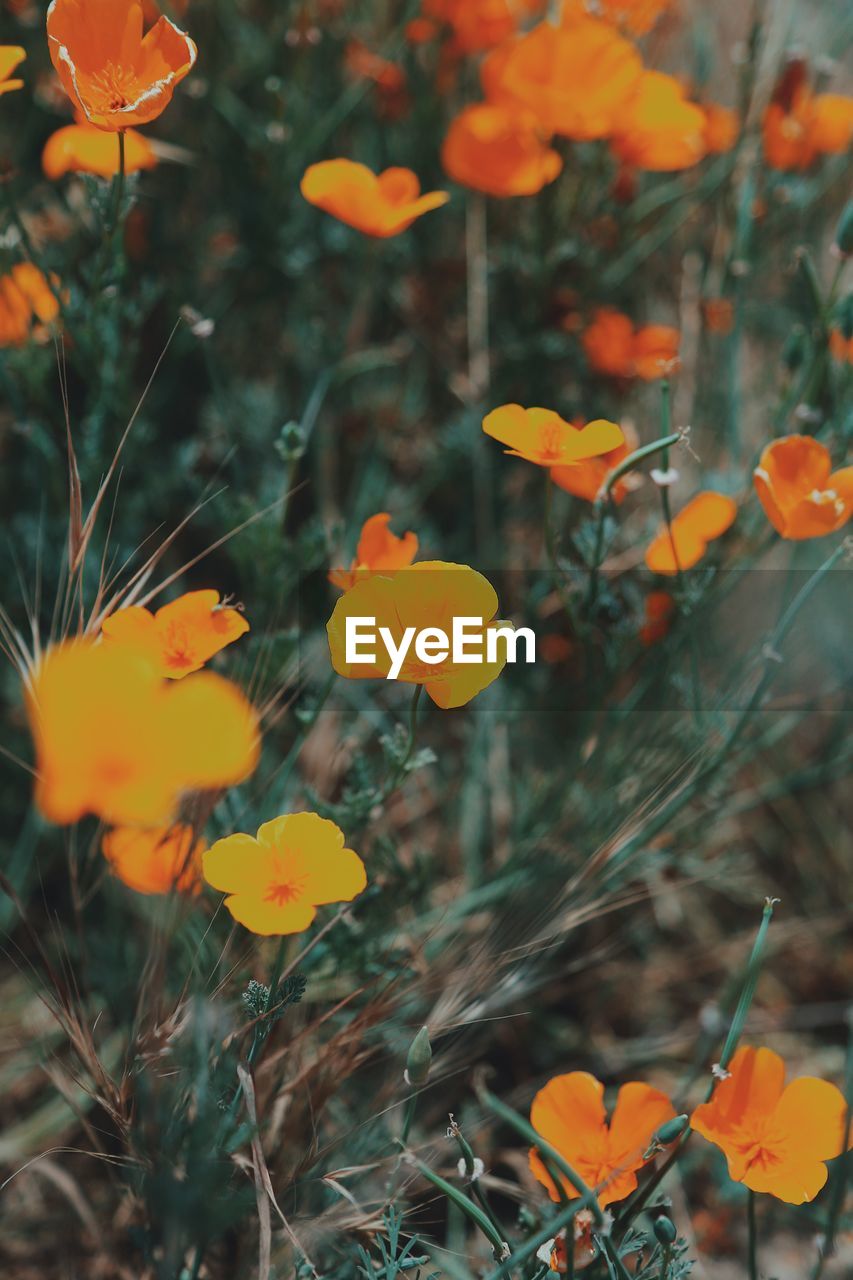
(442, 102, 562, 196)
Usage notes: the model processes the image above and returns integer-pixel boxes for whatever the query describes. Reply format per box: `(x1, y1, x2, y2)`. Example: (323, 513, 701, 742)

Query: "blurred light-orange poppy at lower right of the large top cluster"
(611, 72, 707, 173)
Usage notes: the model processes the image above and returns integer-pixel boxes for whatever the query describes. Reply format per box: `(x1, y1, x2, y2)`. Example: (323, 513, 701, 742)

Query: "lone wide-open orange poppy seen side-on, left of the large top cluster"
(300, 160, 450, 239)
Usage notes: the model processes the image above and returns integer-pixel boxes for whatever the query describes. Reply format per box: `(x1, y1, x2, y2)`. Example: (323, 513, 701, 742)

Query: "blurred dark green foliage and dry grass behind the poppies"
(0, 0, 853, 1280)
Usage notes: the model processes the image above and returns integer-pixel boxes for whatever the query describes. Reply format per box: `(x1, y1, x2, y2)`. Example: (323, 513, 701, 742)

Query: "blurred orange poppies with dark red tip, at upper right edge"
(762, 59, 853, 172)
